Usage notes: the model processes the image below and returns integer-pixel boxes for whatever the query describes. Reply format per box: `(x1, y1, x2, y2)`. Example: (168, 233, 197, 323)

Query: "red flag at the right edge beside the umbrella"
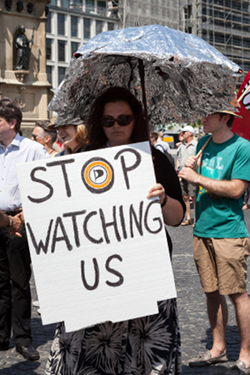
(232, 70, 250, 141)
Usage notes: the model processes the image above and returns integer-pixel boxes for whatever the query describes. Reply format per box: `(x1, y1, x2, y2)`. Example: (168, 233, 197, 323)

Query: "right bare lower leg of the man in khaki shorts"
(229, 293, 250, 367)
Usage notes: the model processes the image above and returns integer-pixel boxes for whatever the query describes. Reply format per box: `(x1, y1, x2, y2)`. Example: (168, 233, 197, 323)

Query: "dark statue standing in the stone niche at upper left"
(15, 25, 34, 70)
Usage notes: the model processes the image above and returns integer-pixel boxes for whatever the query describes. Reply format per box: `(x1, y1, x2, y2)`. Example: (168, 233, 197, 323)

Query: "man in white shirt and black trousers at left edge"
(0, 98, 50, 361)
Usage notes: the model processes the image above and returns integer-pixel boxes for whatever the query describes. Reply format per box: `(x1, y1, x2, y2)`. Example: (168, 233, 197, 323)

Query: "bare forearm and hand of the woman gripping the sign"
(147, 184, 183, 225)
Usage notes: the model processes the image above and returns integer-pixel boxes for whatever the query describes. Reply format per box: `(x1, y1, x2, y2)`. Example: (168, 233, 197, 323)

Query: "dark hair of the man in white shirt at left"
(0, 97, 23, 133)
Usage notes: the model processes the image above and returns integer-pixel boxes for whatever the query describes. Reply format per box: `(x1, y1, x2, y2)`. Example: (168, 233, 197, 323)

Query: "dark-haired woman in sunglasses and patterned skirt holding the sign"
(46, 87, 185, 375)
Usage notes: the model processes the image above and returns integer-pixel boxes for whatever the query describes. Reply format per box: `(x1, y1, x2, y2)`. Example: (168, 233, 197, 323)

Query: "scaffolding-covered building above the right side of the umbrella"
(185, 0, 250, 80)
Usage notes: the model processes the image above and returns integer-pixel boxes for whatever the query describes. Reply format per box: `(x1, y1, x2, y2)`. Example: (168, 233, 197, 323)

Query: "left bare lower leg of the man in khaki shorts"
(206, 291, 228, 358)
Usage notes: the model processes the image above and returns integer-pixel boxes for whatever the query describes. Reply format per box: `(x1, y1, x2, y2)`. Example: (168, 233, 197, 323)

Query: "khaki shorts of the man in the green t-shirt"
(194, 236, 250, 295)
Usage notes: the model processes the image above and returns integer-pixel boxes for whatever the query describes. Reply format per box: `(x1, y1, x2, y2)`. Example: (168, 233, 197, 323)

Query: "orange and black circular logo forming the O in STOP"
(82, 158, 114, 194)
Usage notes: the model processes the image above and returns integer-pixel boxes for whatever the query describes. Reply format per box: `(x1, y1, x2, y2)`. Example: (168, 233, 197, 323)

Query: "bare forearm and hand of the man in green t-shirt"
(179, 167, 248, 199)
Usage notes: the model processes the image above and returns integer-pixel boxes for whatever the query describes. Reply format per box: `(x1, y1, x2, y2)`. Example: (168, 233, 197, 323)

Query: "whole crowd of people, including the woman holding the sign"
(0, 87, 250, 375)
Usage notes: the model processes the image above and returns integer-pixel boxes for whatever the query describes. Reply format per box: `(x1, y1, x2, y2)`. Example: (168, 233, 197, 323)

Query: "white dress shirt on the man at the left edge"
(0, 134, 50, 211)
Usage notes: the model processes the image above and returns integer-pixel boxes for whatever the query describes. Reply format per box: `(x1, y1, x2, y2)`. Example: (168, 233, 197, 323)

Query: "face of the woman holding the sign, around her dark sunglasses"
(102, 102, 135, 147)
